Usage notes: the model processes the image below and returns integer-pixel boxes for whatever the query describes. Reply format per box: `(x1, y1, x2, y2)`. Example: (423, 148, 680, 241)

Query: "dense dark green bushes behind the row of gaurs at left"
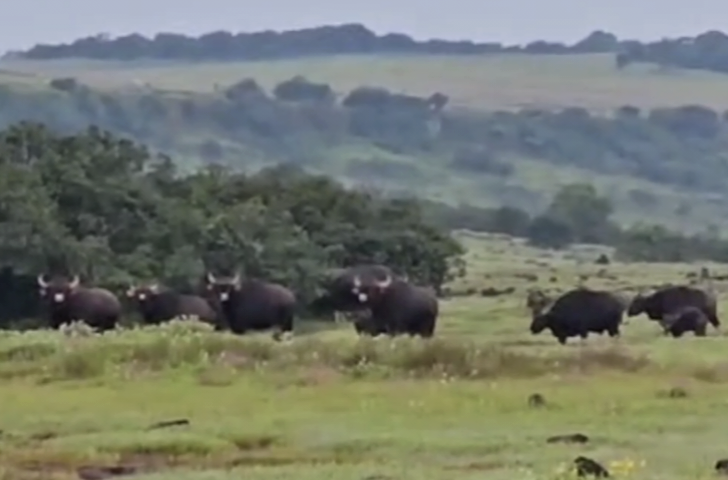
(0, 123, 464, 328)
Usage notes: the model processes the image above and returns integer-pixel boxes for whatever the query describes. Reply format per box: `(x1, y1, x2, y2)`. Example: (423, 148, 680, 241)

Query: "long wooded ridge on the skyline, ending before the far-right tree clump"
(12, 23, 619, 60)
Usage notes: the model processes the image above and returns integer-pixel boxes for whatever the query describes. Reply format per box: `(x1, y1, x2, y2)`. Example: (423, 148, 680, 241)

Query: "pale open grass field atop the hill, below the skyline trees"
(0, 55, 728, 110)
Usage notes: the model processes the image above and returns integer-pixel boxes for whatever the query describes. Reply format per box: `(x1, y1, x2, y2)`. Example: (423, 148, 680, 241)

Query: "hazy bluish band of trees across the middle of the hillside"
(0, 77, 728, 208)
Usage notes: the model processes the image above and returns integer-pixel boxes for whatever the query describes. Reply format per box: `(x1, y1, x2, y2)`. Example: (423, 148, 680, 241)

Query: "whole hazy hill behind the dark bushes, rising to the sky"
(0, 25, 728, 229)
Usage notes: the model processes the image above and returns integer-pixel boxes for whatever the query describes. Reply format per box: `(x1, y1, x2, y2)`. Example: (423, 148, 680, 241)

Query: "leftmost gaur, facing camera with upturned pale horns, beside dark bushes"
(38, 274, 121, 331)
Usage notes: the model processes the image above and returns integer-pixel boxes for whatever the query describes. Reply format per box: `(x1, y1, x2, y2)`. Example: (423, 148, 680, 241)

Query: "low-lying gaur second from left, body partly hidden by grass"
(126, 284, 218, 326)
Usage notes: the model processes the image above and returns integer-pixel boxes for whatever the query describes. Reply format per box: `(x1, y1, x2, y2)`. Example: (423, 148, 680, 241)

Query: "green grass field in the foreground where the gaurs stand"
(0, 231, 728, 480)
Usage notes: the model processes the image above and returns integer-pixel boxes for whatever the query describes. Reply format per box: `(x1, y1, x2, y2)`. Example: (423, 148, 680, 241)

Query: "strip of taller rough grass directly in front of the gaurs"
(0, 320, 684, 381)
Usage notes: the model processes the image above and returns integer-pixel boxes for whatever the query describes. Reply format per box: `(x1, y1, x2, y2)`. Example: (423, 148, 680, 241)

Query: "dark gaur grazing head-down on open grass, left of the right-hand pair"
(531, 288, 625, 344)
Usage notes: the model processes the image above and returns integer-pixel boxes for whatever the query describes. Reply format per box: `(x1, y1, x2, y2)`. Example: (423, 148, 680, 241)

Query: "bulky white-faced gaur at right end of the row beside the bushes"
(353, 276, 439, 338)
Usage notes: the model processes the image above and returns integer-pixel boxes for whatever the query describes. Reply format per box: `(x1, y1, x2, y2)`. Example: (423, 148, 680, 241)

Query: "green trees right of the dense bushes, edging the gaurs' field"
(424, 183, 728, 262)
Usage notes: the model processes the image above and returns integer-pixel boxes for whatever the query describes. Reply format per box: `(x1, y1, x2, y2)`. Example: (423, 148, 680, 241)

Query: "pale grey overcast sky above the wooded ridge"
(0, 0, 728, 51)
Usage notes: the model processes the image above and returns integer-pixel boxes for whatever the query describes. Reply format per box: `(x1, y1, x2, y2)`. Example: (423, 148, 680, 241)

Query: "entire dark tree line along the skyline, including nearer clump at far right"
(11, 23, 728, 73)
